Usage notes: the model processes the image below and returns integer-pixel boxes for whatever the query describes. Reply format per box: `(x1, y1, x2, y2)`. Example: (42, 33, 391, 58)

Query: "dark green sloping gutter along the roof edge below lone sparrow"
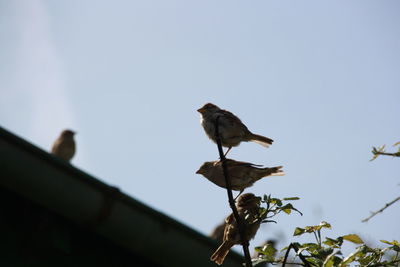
(0, 127, 242, 266)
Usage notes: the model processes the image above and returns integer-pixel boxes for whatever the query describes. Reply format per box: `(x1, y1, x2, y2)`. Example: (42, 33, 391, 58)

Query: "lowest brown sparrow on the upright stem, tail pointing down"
(210, 193, 261, 265)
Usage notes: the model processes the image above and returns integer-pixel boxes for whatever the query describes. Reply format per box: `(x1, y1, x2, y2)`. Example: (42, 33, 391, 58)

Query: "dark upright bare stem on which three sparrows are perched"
(215, 117, 252, 267)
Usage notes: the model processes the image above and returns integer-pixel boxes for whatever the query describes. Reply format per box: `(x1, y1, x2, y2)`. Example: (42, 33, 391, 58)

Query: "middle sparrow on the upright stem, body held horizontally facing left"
(196, 159, 285, 194)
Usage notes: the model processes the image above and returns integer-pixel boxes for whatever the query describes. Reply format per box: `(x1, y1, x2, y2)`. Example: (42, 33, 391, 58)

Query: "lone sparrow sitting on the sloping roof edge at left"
(51, 129, 76, 161)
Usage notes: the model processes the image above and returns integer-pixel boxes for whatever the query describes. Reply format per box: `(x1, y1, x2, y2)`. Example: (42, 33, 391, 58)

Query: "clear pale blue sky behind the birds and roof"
(0, 0, 400, 260)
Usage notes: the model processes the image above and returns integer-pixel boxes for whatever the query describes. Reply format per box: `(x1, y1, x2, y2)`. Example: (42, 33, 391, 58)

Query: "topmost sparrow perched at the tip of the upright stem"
(197, 103, 273, 155)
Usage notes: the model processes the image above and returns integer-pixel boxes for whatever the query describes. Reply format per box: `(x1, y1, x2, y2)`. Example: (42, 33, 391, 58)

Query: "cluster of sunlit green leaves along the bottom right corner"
(253, 222, 400, 267)
